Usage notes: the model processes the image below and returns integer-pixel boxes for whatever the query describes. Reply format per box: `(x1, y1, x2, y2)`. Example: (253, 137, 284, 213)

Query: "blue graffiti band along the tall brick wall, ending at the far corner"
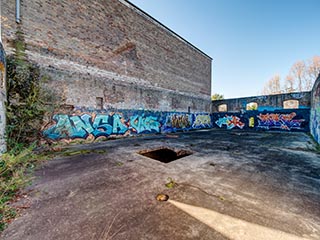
(43, 110, 212, 140)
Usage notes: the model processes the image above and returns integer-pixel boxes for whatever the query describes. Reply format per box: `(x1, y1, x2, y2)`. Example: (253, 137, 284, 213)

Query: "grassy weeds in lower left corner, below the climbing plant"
(0, 145, 42, 232)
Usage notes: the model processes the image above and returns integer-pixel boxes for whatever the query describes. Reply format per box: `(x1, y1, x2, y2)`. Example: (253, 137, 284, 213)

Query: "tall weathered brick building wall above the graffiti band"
(2, 0, 211, 111)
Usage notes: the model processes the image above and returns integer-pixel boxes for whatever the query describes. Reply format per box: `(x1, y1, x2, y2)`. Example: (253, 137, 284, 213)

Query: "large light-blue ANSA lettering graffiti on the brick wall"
(43, 113, 161, 140)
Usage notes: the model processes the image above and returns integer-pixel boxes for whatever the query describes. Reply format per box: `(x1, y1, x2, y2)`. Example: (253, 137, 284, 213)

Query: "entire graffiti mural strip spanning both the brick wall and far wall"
(43, 109, 310, 140)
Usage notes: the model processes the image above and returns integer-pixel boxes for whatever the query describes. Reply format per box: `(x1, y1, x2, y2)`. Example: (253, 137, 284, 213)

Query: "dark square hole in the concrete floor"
(139, 148, 192, 163)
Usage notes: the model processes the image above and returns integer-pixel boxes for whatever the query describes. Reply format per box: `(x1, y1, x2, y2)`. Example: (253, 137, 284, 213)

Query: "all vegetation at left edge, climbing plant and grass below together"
(0, 30, 54, 232)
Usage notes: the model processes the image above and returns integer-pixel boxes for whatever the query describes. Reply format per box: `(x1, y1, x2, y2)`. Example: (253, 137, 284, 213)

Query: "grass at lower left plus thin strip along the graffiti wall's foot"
(0, 145, 106, 233)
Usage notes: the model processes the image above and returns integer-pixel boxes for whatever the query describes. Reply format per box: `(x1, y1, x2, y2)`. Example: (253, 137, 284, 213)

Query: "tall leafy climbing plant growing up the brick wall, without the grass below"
(6, 28, 53, 152)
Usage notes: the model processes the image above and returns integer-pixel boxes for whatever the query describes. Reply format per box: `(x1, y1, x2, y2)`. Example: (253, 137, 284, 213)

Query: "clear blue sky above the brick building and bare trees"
(130, 0, 320, 98)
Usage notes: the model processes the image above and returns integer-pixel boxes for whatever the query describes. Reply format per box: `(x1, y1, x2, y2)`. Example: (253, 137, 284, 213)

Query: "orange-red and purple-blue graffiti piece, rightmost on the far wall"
(257, 112, 305, 130)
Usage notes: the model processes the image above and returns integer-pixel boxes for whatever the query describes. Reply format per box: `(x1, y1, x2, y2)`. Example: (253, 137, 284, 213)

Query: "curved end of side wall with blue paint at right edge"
(310, 74, 320, 144)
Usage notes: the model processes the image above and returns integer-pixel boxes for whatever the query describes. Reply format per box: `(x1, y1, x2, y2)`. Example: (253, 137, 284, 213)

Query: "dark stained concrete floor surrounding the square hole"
(2, 130, 320, 240)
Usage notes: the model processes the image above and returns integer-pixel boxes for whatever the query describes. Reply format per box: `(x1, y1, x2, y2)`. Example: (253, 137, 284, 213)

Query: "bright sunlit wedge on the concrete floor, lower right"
(168, 200, 311, 240)
